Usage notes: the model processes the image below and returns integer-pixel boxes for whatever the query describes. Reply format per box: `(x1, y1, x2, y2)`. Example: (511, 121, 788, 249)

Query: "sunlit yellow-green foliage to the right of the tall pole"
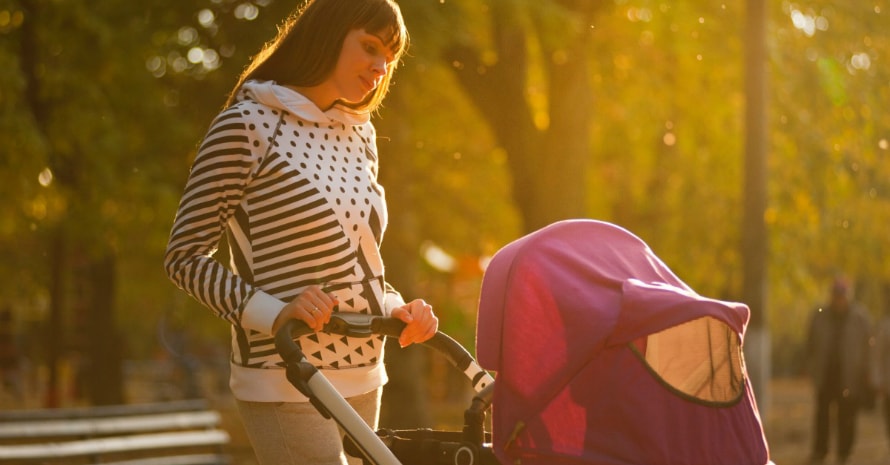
(767, 2, 890, 358)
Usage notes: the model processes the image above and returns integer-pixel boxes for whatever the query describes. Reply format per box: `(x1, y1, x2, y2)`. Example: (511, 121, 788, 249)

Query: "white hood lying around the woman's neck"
(241, 81, 371, 126)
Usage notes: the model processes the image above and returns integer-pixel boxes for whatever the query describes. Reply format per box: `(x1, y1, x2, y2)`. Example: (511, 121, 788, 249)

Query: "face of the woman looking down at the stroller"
(319, 29, 394, 104)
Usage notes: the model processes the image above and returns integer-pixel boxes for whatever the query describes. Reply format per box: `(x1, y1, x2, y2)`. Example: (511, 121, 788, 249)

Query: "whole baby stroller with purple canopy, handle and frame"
(277, 220, 771, 465)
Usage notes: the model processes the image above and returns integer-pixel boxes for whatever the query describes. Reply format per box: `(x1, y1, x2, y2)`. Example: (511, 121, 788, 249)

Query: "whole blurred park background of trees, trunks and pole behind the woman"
(0, 0, 890, 462)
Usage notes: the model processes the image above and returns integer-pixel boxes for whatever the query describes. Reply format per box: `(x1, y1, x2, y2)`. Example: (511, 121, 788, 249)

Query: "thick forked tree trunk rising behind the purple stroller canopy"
(446, 1, 592, 232)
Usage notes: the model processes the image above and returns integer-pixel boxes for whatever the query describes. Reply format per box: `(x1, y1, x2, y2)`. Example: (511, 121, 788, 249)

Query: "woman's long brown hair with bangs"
(226, 0, 408, 111)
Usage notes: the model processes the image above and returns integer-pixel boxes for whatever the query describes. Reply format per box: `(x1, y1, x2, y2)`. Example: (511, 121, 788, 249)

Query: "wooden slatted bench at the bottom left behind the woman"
(0, 400, 230, 465)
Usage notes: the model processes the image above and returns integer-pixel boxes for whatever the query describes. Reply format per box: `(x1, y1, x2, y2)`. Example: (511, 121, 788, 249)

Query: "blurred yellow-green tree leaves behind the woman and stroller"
(0, 0, 890, 364)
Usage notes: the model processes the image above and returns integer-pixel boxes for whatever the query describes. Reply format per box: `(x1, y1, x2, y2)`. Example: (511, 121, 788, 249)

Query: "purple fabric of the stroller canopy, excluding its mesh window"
(476, 220, 768, 465)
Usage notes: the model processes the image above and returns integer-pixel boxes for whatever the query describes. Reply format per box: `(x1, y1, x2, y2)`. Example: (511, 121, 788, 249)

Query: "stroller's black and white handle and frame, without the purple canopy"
(275, 312, 498, 465)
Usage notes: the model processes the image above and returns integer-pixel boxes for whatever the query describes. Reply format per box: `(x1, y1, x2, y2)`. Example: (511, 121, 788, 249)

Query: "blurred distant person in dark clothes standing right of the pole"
(807, 278, 871, 464)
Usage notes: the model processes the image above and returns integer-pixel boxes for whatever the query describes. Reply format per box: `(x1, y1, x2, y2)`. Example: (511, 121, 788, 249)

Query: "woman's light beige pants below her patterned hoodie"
(238, 389, 382, 465)
